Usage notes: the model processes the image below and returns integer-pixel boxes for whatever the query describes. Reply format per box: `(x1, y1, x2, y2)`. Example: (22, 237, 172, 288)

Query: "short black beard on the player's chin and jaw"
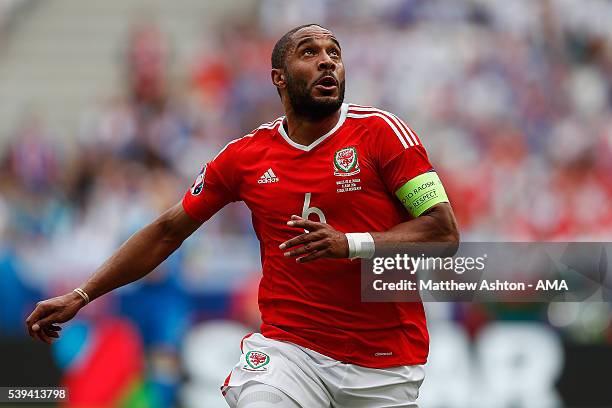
(287, 74, 344, 121)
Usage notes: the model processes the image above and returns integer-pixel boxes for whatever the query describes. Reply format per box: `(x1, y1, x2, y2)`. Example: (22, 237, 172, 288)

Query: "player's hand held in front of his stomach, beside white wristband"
(279, 215, 348, 263)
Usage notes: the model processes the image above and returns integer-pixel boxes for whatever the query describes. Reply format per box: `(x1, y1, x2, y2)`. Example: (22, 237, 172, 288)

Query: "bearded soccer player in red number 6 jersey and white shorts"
(26, 24, 459, 408)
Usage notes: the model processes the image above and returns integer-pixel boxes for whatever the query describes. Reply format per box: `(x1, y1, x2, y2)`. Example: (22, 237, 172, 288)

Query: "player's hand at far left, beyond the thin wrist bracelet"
(26, 292, 85, 344)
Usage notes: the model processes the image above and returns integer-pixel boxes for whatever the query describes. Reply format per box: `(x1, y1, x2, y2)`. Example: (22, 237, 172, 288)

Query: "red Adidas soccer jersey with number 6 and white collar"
(183, 104, 432, 368)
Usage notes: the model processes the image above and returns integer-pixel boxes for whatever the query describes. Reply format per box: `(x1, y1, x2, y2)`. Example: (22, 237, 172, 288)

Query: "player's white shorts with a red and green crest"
(221, 333, 425, 408)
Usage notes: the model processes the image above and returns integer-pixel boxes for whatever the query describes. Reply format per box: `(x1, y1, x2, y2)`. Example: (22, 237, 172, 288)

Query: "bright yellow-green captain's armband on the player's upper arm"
(395, 171, 448, 217)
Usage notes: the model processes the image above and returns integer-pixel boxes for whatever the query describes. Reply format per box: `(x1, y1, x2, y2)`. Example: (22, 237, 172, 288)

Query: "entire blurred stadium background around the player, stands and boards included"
(0, 0, 612, 408)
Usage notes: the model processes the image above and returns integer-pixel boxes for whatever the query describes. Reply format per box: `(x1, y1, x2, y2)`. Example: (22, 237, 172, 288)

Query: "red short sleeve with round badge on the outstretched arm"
(182, 142, 239, 222)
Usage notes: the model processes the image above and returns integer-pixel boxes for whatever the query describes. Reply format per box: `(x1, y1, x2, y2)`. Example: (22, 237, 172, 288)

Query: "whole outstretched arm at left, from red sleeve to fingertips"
(26, 135, 240, 344)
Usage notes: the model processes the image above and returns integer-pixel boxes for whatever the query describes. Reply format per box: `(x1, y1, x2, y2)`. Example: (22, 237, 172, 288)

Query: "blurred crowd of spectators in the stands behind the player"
(0, 0, 612, 406)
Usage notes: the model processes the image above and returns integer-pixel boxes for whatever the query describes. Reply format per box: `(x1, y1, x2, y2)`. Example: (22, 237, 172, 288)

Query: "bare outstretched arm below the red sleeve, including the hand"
(26, 202, 202, 344)
